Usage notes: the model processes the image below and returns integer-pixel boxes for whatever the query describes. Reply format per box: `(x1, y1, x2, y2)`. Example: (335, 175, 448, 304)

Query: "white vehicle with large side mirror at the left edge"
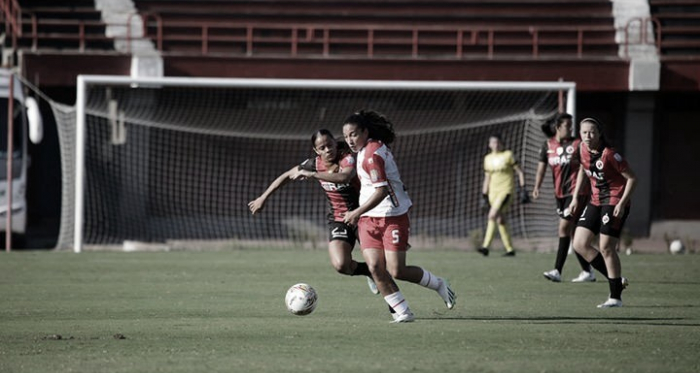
(0, 69, 43, 238)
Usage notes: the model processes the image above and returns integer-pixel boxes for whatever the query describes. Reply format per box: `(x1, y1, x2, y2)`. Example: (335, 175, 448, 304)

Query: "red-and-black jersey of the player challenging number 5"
(299, 153, 360, 222)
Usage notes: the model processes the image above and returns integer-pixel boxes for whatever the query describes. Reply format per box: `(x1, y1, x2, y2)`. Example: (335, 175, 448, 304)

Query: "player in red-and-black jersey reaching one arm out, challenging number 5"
(248, 129, 379, 294)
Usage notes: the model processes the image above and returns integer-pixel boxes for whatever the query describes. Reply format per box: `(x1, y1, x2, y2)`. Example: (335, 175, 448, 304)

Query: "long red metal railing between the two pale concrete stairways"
(134, 16, 617, 59)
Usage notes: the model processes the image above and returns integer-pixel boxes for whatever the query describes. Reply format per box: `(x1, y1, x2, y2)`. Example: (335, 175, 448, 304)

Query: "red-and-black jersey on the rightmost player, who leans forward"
(579, 146, 629, 206)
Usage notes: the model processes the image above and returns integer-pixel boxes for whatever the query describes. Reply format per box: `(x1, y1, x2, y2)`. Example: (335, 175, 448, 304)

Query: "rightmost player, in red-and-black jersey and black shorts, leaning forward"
(569, 118, 637, 308)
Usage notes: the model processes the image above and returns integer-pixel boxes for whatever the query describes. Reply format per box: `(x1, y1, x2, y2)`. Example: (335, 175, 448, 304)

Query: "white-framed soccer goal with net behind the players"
(55, 76, 575, 251)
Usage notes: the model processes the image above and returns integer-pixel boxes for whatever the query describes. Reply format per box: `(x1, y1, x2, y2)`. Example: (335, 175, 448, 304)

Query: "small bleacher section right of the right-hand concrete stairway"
(649, 0, 700, 57)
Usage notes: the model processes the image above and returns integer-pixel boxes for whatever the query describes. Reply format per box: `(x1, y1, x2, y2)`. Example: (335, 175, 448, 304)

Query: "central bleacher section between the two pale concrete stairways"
(135, 0, 618, 58)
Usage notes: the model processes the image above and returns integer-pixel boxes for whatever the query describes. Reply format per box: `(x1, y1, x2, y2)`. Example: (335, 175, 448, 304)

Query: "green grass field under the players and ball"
(0, 250, 700, 373)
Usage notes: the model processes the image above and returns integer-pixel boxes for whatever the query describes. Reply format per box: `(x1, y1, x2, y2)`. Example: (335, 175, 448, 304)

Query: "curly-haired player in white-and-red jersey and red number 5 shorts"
(343, 110, 456, 323)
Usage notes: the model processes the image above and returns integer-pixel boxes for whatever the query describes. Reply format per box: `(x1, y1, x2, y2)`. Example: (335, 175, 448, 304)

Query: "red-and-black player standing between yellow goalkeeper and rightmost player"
(532, 114, 595, 282)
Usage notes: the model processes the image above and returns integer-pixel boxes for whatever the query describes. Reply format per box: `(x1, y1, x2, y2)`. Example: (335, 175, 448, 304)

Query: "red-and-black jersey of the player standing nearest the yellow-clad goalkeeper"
(540, 136, 589, 198)
